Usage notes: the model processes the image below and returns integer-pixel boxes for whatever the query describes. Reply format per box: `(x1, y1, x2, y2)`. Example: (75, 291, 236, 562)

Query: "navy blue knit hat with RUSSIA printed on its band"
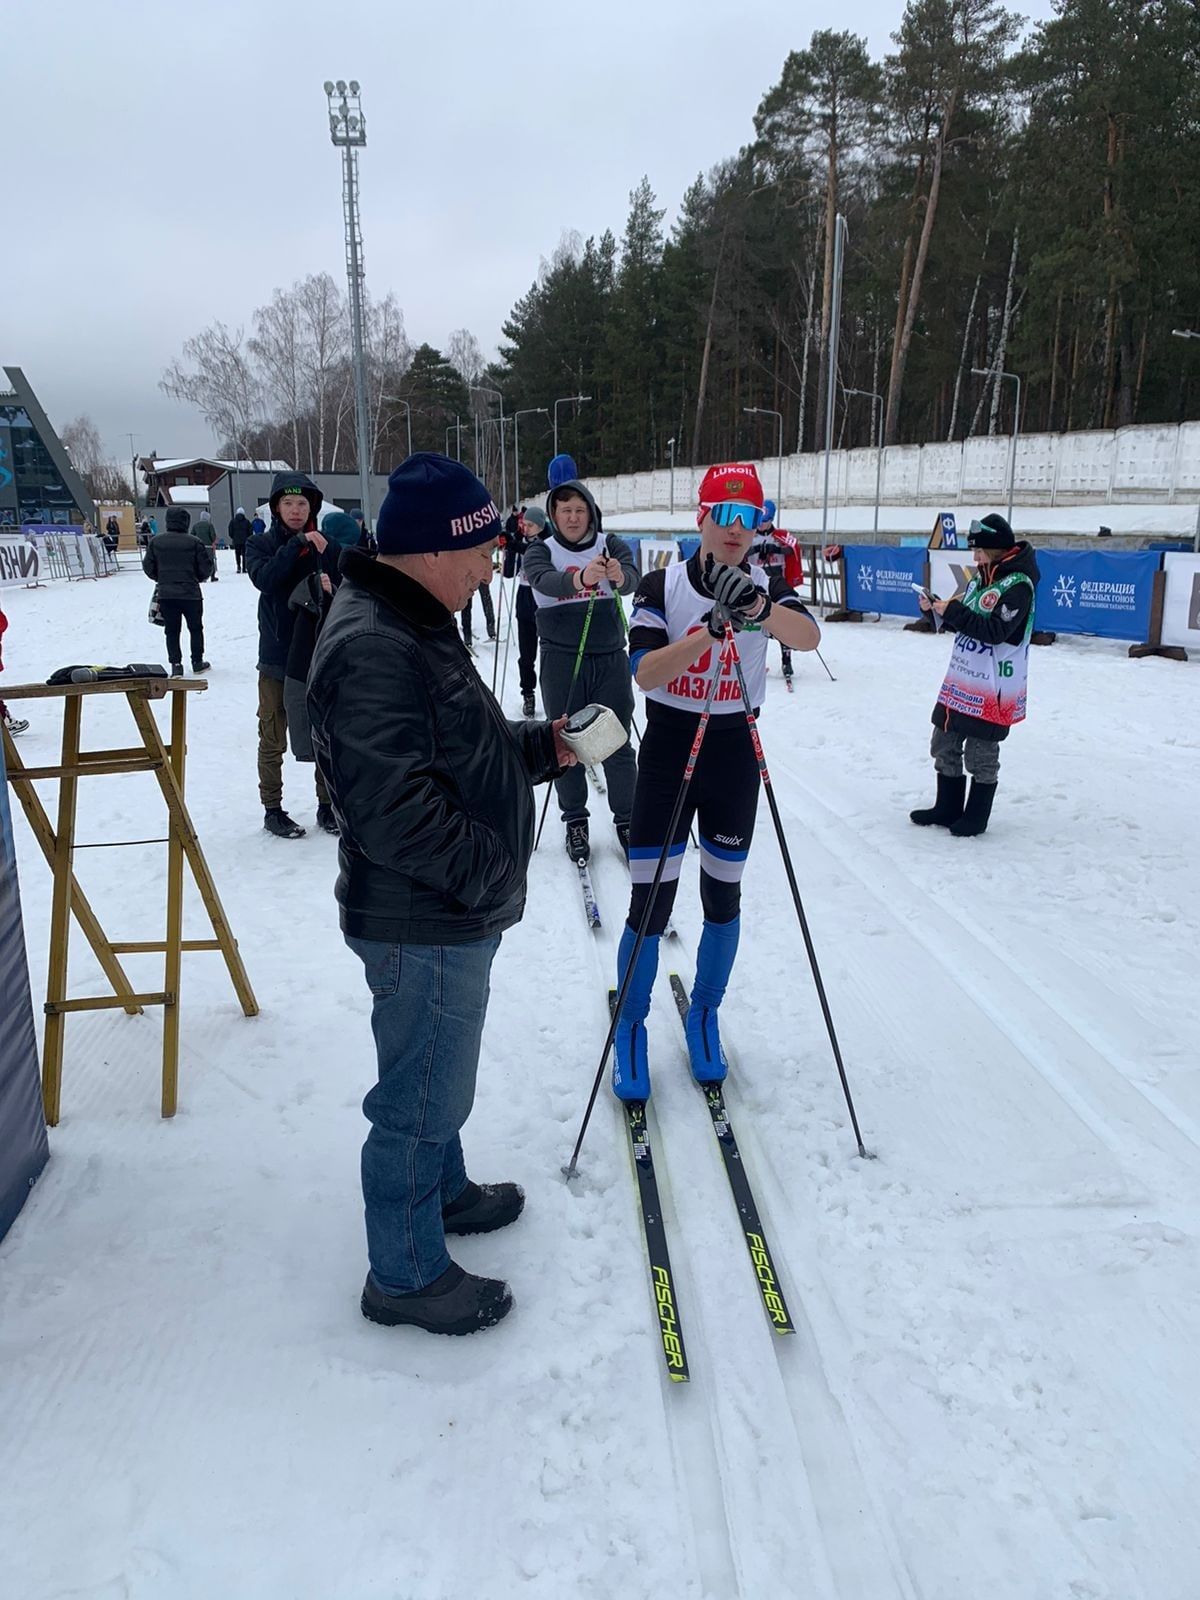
(374, 450, 502, 555)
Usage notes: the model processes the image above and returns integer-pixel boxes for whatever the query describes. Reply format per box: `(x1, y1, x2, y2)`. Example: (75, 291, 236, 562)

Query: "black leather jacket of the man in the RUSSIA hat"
(309, 550, 558, 944)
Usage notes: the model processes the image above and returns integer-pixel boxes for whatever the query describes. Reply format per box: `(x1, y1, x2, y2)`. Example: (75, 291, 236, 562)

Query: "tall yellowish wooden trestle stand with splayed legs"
(3, 678, 258, 1128)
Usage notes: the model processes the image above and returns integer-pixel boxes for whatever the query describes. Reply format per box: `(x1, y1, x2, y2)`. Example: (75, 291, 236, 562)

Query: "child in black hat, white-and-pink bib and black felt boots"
(909, 512, 1042, 838)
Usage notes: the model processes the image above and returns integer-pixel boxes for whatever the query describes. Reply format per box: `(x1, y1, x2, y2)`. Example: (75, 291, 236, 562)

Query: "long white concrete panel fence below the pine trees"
(587, 422, 1200, 512)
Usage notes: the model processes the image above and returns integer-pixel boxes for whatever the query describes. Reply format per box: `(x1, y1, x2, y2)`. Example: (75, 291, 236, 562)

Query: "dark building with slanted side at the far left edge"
(0, 366, 96, 528)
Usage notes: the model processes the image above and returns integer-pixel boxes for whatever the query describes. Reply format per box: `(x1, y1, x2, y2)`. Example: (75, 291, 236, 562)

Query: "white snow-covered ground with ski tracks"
(0, 555, 1200, 1600)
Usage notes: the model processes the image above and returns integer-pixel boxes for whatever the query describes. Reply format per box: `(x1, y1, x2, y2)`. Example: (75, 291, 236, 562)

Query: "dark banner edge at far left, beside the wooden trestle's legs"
(0, 741, 50, 1238)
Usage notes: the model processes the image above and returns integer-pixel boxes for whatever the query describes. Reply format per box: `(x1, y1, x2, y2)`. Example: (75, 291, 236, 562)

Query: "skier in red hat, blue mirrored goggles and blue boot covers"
(613, 462, 821, 1101)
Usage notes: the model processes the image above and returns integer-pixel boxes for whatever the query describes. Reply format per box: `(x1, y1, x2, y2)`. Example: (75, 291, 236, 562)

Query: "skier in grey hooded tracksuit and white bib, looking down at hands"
(525, 478, 638, 861)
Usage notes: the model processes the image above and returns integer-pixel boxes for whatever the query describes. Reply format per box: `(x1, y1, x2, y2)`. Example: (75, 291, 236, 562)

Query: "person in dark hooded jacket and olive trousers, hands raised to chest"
(246, 472, 330, 838)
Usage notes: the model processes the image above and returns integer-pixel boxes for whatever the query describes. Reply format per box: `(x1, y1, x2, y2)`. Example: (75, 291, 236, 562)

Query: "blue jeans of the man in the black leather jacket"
(346, 934, 499, 1294)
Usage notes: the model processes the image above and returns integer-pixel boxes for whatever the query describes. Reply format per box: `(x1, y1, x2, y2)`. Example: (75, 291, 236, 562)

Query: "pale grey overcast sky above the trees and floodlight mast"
(0, 0, 1051, 458)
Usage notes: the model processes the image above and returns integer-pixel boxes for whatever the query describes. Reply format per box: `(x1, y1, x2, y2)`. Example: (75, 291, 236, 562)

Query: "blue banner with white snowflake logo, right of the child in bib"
(1035, 550, 1162, 642)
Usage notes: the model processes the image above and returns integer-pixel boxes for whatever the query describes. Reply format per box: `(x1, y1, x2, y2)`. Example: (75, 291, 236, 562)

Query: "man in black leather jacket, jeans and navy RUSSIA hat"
(307, 453, 573, 1333)
